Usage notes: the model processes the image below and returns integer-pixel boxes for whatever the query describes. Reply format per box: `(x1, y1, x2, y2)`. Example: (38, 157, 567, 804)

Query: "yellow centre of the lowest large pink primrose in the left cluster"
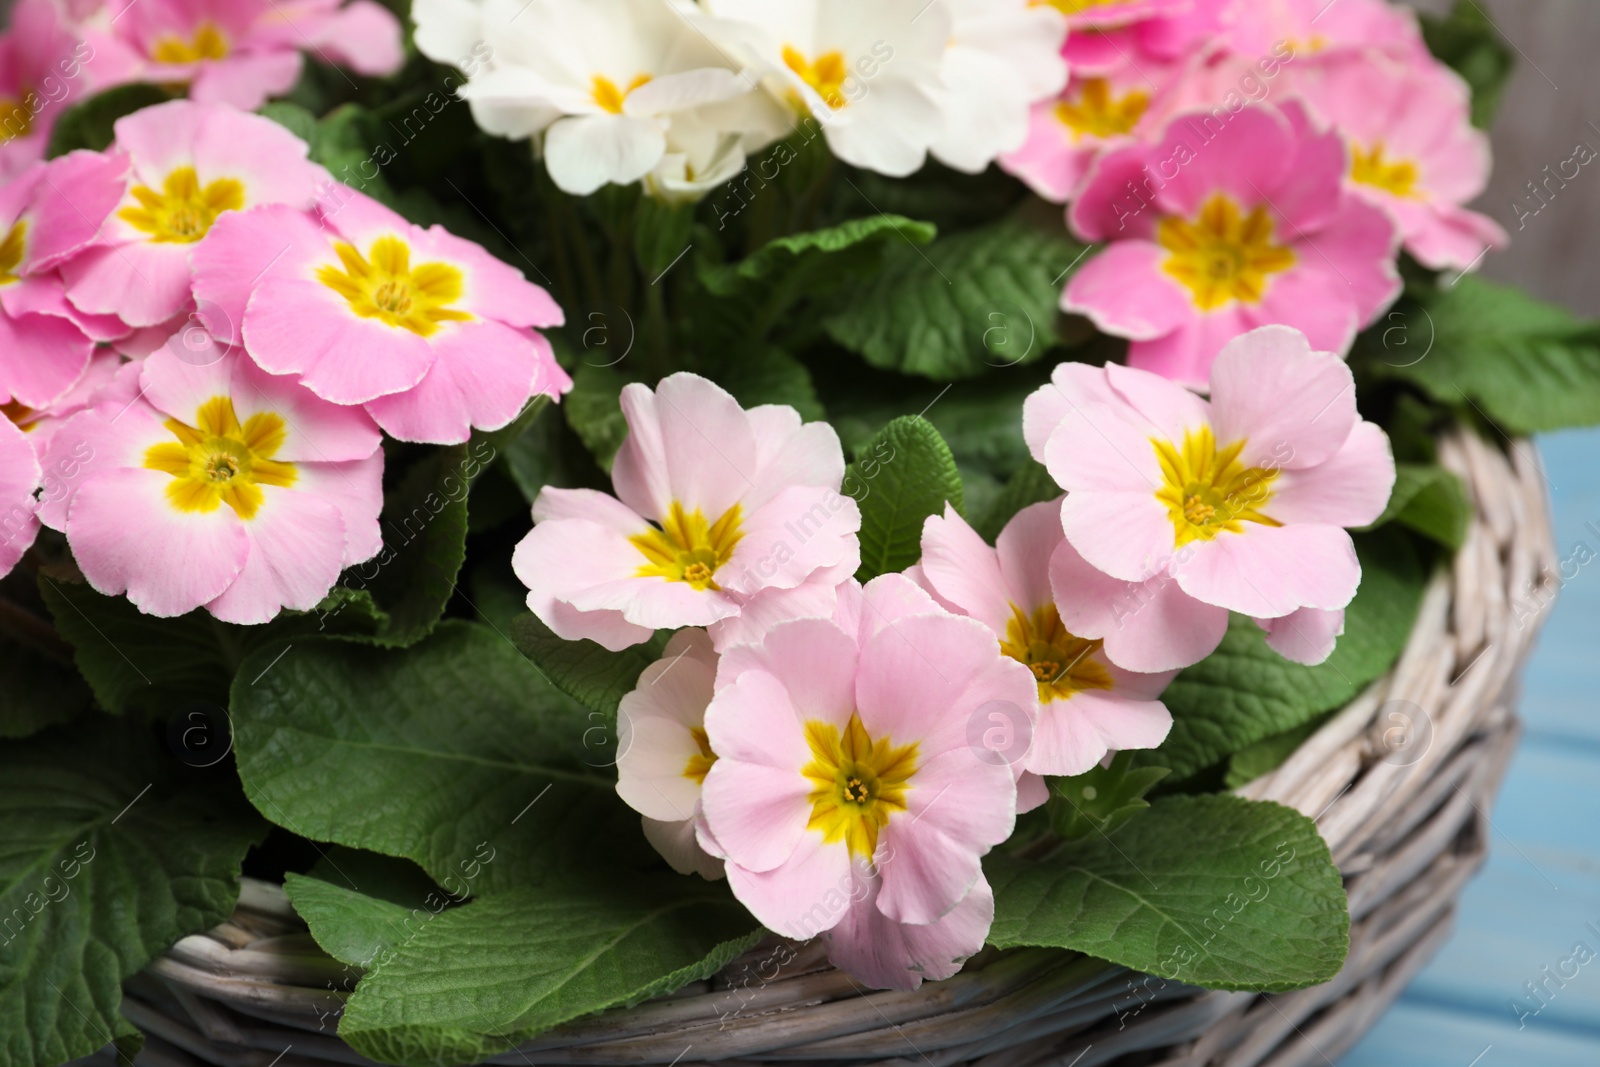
(144, 397, 299, 520)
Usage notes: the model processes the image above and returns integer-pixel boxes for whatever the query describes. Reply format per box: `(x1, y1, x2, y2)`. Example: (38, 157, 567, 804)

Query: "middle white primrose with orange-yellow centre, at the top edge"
(701, 0, 952, 178)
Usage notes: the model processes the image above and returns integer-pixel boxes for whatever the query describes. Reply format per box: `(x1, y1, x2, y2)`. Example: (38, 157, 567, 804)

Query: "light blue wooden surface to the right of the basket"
(1339, 430, 1600, 1067)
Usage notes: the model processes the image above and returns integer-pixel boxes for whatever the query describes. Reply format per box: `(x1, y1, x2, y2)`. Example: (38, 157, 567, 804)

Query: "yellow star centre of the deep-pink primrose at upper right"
(1155, 194, 1294, 312)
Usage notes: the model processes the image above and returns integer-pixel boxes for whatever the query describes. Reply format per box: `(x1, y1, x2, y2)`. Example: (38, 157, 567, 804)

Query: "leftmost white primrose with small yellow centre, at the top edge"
(414, 0, 754, 195)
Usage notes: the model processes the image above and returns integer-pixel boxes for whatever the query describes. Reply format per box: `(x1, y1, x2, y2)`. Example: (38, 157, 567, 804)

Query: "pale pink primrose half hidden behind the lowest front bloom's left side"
(616, 629, 722, 878)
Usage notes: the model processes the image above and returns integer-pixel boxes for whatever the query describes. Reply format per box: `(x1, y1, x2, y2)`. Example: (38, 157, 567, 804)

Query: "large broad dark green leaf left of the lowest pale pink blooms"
(230, 621, 649, 894)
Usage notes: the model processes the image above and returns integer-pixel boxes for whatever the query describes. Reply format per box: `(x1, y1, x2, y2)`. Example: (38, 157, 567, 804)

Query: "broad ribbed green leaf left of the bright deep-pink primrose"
(826, 218, 1083, 381)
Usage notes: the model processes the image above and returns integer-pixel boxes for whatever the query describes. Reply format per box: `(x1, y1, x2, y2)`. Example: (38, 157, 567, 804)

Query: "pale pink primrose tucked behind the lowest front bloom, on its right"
(922, 502, 1174, 776)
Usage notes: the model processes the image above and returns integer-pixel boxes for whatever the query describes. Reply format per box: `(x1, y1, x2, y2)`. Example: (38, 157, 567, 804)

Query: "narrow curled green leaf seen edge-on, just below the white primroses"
(691, 214, 934, 350)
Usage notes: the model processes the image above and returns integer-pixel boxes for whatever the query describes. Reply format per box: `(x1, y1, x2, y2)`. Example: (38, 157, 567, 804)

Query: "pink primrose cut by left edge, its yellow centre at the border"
(0, 152, 128, 410)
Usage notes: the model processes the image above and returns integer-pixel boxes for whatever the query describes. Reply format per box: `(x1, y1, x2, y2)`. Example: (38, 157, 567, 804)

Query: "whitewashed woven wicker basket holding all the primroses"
(87, 434, 1555, 1067)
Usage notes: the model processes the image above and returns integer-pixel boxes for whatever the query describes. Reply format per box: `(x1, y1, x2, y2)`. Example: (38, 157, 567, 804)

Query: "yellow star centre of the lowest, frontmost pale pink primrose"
(800, 715, 917, 859)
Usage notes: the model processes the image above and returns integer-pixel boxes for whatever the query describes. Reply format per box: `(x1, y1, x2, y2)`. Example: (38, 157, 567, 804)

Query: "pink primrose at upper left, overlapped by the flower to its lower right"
(61, 101, 328, 326)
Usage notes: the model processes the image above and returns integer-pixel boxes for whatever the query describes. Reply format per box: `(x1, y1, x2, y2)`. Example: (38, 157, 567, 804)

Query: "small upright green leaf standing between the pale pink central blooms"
(843, 414, 962, 582)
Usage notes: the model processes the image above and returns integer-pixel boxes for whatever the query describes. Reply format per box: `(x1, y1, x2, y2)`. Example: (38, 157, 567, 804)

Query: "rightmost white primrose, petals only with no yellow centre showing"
(933, 0, 1067, 174)
